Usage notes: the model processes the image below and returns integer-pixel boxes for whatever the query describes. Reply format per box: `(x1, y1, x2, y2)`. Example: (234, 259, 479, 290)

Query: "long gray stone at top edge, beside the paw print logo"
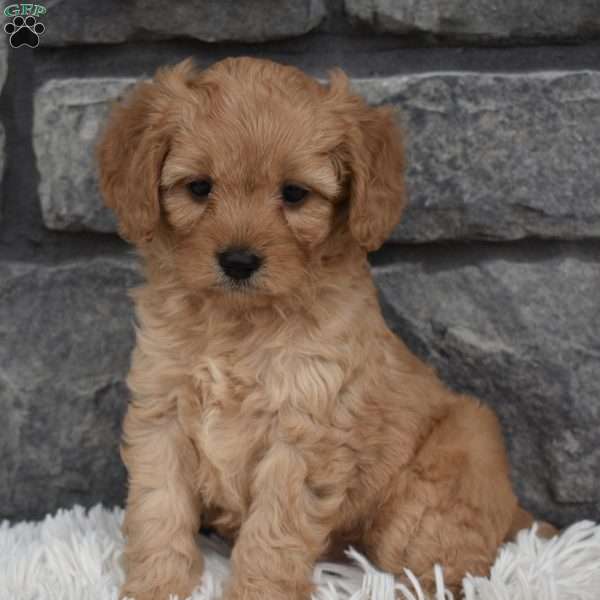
(41, 0, 326, 46)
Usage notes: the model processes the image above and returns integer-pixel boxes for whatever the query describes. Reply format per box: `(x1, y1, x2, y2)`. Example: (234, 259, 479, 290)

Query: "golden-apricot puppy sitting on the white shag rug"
(99, 58, 531, 600)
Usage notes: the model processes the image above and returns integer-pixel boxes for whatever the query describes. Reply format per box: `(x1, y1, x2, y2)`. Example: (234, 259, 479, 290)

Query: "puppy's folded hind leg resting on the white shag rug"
(364, 397, 517, 591)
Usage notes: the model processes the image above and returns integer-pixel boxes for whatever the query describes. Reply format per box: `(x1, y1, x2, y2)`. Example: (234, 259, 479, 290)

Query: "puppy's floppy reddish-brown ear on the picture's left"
(98, 61, 193, 243)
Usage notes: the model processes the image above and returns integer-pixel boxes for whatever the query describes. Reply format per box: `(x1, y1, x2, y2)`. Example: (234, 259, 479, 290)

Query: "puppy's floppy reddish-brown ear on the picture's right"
(330, 71, 406, 251)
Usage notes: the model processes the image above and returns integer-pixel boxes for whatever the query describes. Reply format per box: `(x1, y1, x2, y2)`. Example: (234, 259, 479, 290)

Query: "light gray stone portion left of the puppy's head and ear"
(33, 78, 135, 232)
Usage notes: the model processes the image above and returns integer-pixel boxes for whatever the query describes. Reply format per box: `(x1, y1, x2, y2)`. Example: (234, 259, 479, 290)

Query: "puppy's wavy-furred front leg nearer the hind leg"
(225, 442, 343, 600)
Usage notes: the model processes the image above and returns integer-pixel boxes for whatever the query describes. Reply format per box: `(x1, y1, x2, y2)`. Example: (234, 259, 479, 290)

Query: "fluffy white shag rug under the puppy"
(0, 506, 600, 600)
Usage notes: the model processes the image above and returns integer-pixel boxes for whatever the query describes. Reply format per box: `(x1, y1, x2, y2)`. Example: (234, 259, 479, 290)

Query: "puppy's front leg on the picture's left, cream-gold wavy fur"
(121, 404, 202, 600)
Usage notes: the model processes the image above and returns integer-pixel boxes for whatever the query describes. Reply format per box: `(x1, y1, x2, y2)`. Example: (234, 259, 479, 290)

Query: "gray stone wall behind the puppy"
(0, 0, 600, 524)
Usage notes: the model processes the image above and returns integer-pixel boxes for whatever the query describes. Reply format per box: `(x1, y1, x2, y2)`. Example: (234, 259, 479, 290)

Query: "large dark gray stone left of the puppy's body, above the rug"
(0, 258, 139, 520)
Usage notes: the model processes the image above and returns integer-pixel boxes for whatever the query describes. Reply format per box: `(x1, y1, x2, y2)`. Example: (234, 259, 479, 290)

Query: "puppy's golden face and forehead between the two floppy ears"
(160, 71, 342, 295)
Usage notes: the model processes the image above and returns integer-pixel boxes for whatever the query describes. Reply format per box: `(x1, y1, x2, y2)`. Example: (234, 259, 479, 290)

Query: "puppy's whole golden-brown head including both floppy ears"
(99, 58, 404, 297)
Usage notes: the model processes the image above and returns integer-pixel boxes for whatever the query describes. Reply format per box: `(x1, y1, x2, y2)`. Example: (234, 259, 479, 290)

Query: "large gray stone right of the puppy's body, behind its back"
(374, 246, 600, 525)
